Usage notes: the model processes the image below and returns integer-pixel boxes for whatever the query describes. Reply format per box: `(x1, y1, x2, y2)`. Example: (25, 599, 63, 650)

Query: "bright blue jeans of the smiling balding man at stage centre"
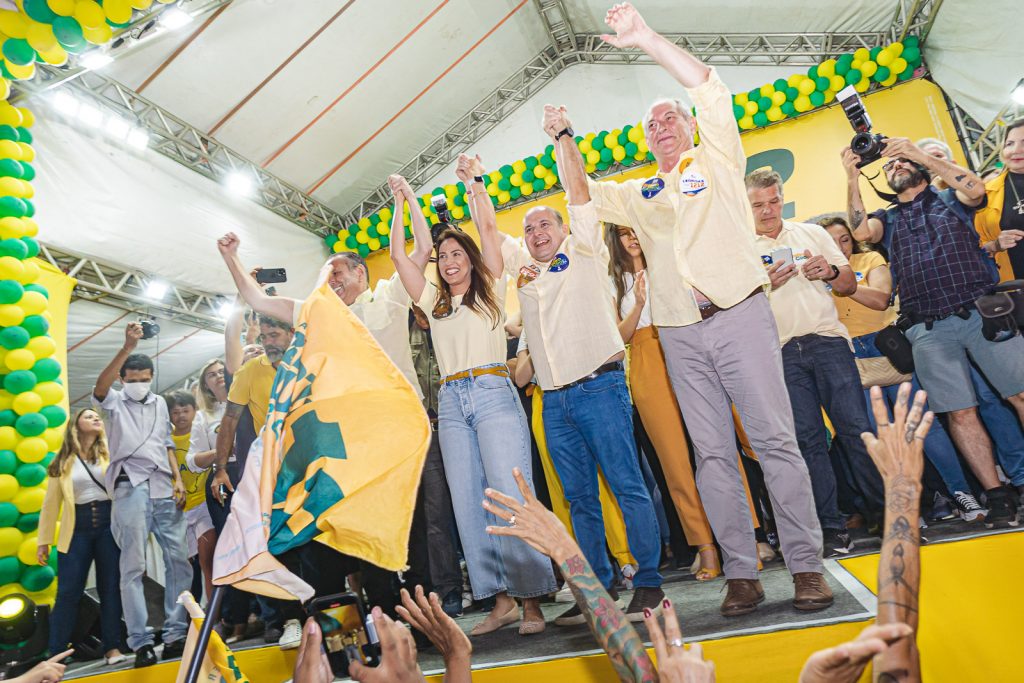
(544, 370, 662, 588)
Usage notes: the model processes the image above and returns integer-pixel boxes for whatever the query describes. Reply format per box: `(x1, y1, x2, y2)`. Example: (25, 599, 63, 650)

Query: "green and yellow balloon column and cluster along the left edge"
(0, 0, 183, 604)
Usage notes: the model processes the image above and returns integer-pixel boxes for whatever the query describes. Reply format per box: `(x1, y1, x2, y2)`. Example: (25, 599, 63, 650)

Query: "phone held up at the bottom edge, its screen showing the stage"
(309, 593, 381, 678)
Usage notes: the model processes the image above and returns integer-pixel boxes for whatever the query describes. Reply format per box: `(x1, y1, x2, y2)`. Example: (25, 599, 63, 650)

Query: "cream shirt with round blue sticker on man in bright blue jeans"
(502, 203, 625, 391)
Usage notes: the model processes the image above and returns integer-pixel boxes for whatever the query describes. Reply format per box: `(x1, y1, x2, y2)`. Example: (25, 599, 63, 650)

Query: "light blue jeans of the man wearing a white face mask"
(111, 482, 191, 650)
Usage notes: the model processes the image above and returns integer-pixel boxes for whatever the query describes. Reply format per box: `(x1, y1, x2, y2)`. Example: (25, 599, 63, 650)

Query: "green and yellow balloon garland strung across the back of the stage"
(326, 36, 922, 256)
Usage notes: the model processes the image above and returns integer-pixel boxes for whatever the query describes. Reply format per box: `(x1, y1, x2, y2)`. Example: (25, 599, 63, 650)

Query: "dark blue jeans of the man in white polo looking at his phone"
(782, 335, 885, 529)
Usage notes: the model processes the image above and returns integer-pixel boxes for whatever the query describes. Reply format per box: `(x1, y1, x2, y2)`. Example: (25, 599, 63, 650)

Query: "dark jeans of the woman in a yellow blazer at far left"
(49, 501, 123, 654)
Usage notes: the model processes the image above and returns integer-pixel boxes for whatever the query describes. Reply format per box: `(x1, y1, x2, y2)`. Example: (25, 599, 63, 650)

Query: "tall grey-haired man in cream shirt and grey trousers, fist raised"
(590, 3, 833, 615)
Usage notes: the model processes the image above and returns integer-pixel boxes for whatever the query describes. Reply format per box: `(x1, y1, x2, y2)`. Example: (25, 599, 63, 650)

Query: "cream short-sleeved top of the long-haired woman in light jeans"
(417, 278, 508, 378)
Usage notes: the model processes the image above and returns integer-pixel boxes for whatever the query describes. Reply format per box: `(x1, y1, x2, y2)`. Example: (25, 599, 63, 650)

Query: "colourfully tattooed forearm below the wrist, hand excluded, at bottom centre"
(559, 554, 657, 681)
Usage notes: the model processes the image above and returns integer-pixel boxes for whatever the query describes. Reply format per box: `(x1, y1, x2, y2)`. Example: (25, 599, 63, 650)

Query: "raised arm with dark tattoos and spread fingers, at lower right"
(861, 383, 933, 682)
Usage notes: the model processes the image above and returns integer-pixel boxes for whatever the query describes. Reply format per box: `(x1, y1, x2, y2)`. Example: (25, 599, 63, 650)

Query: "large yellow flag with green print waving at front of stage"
(214, 284, 430, 598)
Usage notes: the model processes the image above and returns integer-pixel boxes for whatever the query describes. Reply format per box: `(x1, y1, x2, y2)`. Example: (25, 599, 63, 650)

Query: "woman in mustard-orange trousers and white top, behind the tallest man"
(604, 224, 754, 581)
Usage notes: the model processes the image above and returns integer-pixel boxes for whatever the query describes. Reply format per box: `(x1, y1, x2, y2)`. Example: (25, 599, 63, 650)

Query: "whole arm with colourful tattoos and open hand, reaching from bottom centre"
(483, 468, 657, 681)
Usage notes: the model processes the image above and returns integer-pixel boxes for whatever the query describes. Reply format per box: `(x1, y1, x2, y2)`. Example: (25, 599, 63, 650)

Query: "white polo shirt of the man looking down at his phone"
(757, 220, 850, 344)
